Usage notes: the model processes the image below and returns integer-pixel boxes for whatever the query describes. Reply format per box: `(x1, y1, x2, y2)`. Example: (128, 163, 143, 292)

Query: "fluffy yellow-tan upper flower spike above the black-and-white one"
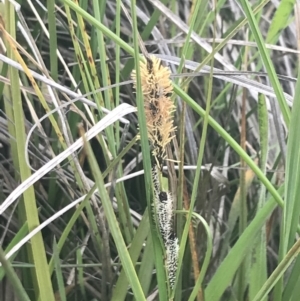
(131, 56, 175, 169)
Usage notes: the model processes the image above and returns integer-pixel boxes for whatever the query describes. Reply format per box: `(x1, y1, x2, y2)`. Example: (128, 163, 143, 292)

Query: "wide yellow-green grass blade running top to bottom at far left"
(6, 2, 54, 301)
